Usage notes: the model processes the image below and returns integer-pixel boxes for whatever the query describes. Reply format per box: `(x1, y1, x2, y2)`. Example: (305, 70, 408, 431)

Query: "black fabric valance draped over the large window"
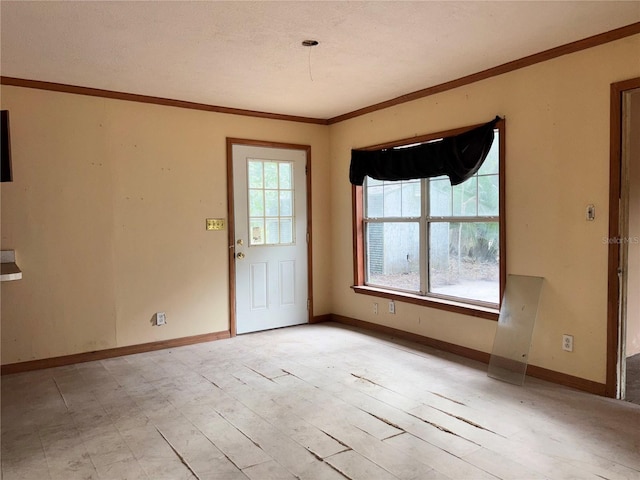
(349, 117, 500, 185)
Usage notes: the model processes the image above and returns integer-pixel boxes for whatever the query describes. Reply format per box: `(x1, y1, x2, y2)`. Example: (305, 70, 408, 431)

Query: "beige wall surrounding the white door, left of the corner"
(1, 86, 331, 364)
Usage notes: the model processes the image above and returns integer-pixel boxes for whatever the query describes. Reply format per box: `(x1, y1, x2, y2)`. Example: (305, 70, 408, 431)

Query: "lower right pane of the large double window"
(429, 222, 500, 304)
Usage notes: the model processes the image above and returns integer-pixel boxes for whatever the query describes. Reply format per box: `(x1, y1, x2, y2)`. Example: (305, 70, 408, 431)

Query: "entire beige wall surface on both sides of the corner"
(1, 36, 640, 382)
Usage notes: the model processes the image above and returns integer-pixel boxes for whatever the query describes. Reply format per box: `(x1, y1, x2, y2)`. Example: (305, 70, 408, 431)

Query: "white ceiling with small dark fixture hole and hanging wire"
(0, 0, 640, 119)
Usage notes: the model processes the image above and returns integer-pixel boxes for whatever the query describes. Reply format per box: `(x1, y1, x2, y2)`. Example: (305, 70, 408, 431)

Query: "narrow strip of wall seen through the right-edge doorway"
(626, 90, 640, 357)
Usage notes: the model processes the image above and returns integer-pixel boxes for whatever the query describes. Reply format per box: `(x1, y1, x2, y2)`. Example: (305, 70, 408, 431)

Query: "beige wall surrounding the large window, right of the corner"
(331, 35, 640, 383)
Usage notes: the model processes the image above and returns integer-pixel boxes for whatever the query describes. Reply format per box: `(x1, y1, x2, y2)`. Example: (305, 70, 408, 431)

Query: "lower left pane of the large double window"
(366, 222, 420, 292)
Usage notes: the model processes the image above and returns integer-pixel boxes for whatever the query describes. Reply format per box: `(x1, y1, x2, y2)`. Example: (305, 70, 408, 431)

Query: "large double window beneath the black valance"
(354, 121, 505, 318)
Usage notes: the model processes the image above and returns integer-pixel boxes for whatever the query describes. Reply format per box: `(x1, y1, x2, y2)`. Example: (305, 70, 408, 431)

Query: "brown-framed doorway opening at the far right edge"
(606, 78, 640, 404)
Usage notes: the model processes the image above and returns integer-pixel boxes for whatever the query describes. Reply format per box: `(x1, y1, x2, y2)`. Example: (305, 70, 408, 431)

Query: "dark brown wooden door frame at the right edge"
(605, 77, 640, 398)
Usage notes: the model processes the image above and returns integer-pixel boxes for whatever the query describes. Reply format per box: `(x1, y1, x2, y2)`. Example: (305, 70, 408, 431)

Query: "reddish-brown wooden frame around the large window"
(351, 118, 507, 321)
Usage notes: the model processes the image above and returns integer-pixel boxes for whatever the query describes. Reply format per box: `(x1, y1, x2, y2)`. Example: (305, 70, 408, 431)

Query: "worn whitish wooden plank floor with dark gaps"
(1, 324, 640, 480)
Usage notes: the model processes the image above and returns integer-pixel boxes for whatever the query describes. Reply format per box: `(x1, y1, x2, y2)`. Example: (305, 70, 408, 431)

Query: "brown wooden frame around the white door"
(227, 137, 313, 337)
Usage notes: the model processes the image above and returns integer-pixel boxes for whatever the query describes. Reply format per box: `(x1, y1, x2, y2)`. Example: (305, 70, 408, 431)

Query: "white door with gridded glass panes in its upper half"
(232, 145, 308, 334)
